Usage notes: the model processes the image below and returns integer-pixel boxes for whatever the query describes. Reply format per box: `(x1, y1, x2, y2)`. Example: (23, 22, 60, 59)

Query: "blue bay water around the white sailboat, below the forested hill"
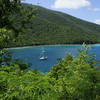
(9, 44, 100, 72)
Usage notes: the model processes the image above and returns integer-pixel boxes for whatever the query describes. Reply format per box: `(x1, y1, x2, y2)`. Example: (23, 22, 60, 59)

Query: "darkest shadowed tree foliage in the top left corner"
(0, 0, 20, 28)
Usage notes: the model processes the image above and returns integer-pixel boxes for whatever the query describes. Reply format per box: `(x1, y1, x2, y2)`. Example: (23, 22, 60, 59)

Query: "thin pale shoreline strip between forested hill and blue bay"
(4, 44, 100, 49)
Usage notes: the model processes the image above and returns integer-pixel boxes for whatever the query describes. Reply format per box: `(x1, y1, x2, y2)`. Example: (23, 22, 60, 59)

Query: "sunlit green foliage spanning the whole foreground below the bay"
(0, 48, 100, 100)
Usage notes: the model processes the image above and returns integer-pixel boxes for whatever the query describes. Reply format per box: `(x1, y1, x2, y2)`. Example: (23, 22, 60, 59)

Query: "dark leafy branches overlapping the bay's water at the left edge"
(0, 49, 30, 72)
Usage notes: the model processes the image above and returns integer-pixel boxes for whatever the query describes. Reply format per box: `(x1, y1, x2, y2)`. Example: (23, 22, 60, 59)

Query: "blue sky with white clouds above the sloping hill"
(23, 0, 100, 25)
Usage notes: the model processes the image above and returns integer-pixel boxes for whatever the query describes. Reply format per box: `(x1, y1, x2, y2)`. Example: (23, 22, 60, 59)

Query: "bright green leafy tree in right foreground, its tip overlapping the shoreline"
(49, 47, 100, 100)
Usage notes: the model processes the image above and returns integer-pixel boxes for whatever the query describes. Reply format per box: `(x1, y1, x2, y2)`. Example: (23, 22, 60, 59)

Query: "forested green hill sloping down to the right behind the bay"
(4, 4, 100, 46)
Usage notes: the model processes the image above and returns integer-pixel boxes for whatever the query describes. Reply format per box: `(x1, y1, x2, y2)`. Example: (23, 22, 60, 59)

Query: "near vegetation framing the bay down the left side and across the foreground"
(0, 0, 100, 100)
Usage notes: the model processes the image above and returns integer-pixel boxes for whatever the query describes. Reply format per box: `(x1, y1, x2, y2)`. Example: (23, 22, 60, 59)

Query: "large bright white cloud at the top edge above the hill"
(52, 0, 91, 9)
